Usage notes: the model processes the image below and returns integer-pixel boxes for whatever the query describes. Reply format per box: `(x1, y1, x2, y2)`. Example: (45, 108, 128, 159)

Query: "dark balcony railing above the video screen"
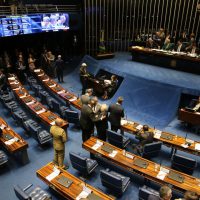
(0, 4, 81, 16)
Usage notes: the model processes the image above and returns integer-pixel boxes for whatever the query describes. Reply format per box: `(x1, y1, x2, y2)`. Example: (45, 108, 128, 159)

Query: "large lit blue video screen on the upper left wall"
(0, 13, 69, 37)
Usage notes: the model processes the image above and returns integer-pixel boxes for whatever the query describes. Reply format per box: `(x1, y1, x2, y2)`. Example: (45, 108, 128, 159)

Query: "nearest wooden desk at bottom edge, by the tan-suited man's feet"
(36, 163, 113, 200)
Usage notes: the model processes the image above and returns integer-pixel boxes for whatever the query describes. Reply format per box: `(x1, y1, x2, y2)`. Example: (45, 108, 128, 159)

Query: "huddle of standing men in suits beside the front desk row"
(80, 89, 124, 142)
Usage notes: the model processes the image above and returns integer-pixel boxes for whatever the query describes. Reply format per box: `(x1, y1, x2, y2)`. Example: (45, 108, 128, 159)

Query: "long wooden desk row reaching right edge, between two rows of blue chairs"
(83, 137, 200, 195)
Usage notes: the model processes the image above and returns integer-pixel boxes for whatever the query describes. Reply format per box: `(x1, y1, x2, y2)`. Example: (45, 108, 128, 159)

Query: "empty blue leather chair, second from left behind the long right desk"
(100, 169, 130, 195)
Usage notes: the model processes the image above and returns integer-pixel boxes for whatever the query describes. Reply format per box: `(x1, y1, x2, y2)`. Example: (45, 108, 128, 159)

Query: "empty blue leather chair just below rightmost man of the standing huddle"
(107, 130, 130, 149)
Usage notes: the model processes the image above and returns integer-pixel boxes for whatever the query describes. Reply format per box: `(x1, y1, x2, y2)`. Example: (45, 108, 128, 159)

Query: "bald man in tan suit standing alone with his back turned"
(50, 118, 67, 169)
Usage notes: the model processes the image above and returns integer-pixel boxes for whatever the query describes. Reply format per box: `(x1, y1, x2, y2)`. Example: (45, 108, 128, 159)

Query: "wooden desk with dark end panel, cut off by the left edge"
(0, 117, 29, 164)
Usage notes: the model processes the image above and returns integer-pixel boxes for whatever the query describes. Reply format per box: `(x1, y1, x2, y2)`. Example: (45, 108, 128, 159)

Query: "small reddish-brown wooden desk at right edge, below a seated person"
(178, 108, 200, 125)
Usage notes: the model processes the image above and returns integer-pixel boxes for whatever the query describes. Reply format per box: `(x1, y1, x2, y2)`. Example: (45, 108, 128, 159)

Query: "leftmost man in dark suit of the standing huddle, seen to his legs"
(80, 98, 99, 142)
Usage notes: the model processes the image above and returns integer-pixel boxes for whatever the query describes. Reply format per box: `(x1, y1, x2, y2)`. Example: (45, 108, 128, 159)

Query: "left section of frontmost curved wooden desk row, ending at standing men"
(33, 69, 81, 110)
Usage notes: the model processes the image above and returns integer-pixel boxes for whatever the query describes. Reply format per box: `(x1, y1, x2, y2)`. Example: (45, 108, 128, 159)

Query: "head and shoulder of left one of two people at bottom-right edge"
(148, 185, 172, 200)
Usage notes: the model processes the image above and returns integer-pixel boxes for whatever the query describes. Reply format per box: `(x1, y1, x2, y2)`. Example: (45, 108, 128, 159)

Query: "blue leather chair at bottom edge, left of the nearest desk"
(14, 184, 52, 200)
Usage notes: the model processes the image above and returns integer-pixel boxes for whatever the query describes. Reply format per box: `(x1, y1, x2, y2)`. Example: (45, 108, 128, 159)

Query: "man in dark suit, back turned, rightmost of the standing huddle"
(108, 97, 124, 132)
